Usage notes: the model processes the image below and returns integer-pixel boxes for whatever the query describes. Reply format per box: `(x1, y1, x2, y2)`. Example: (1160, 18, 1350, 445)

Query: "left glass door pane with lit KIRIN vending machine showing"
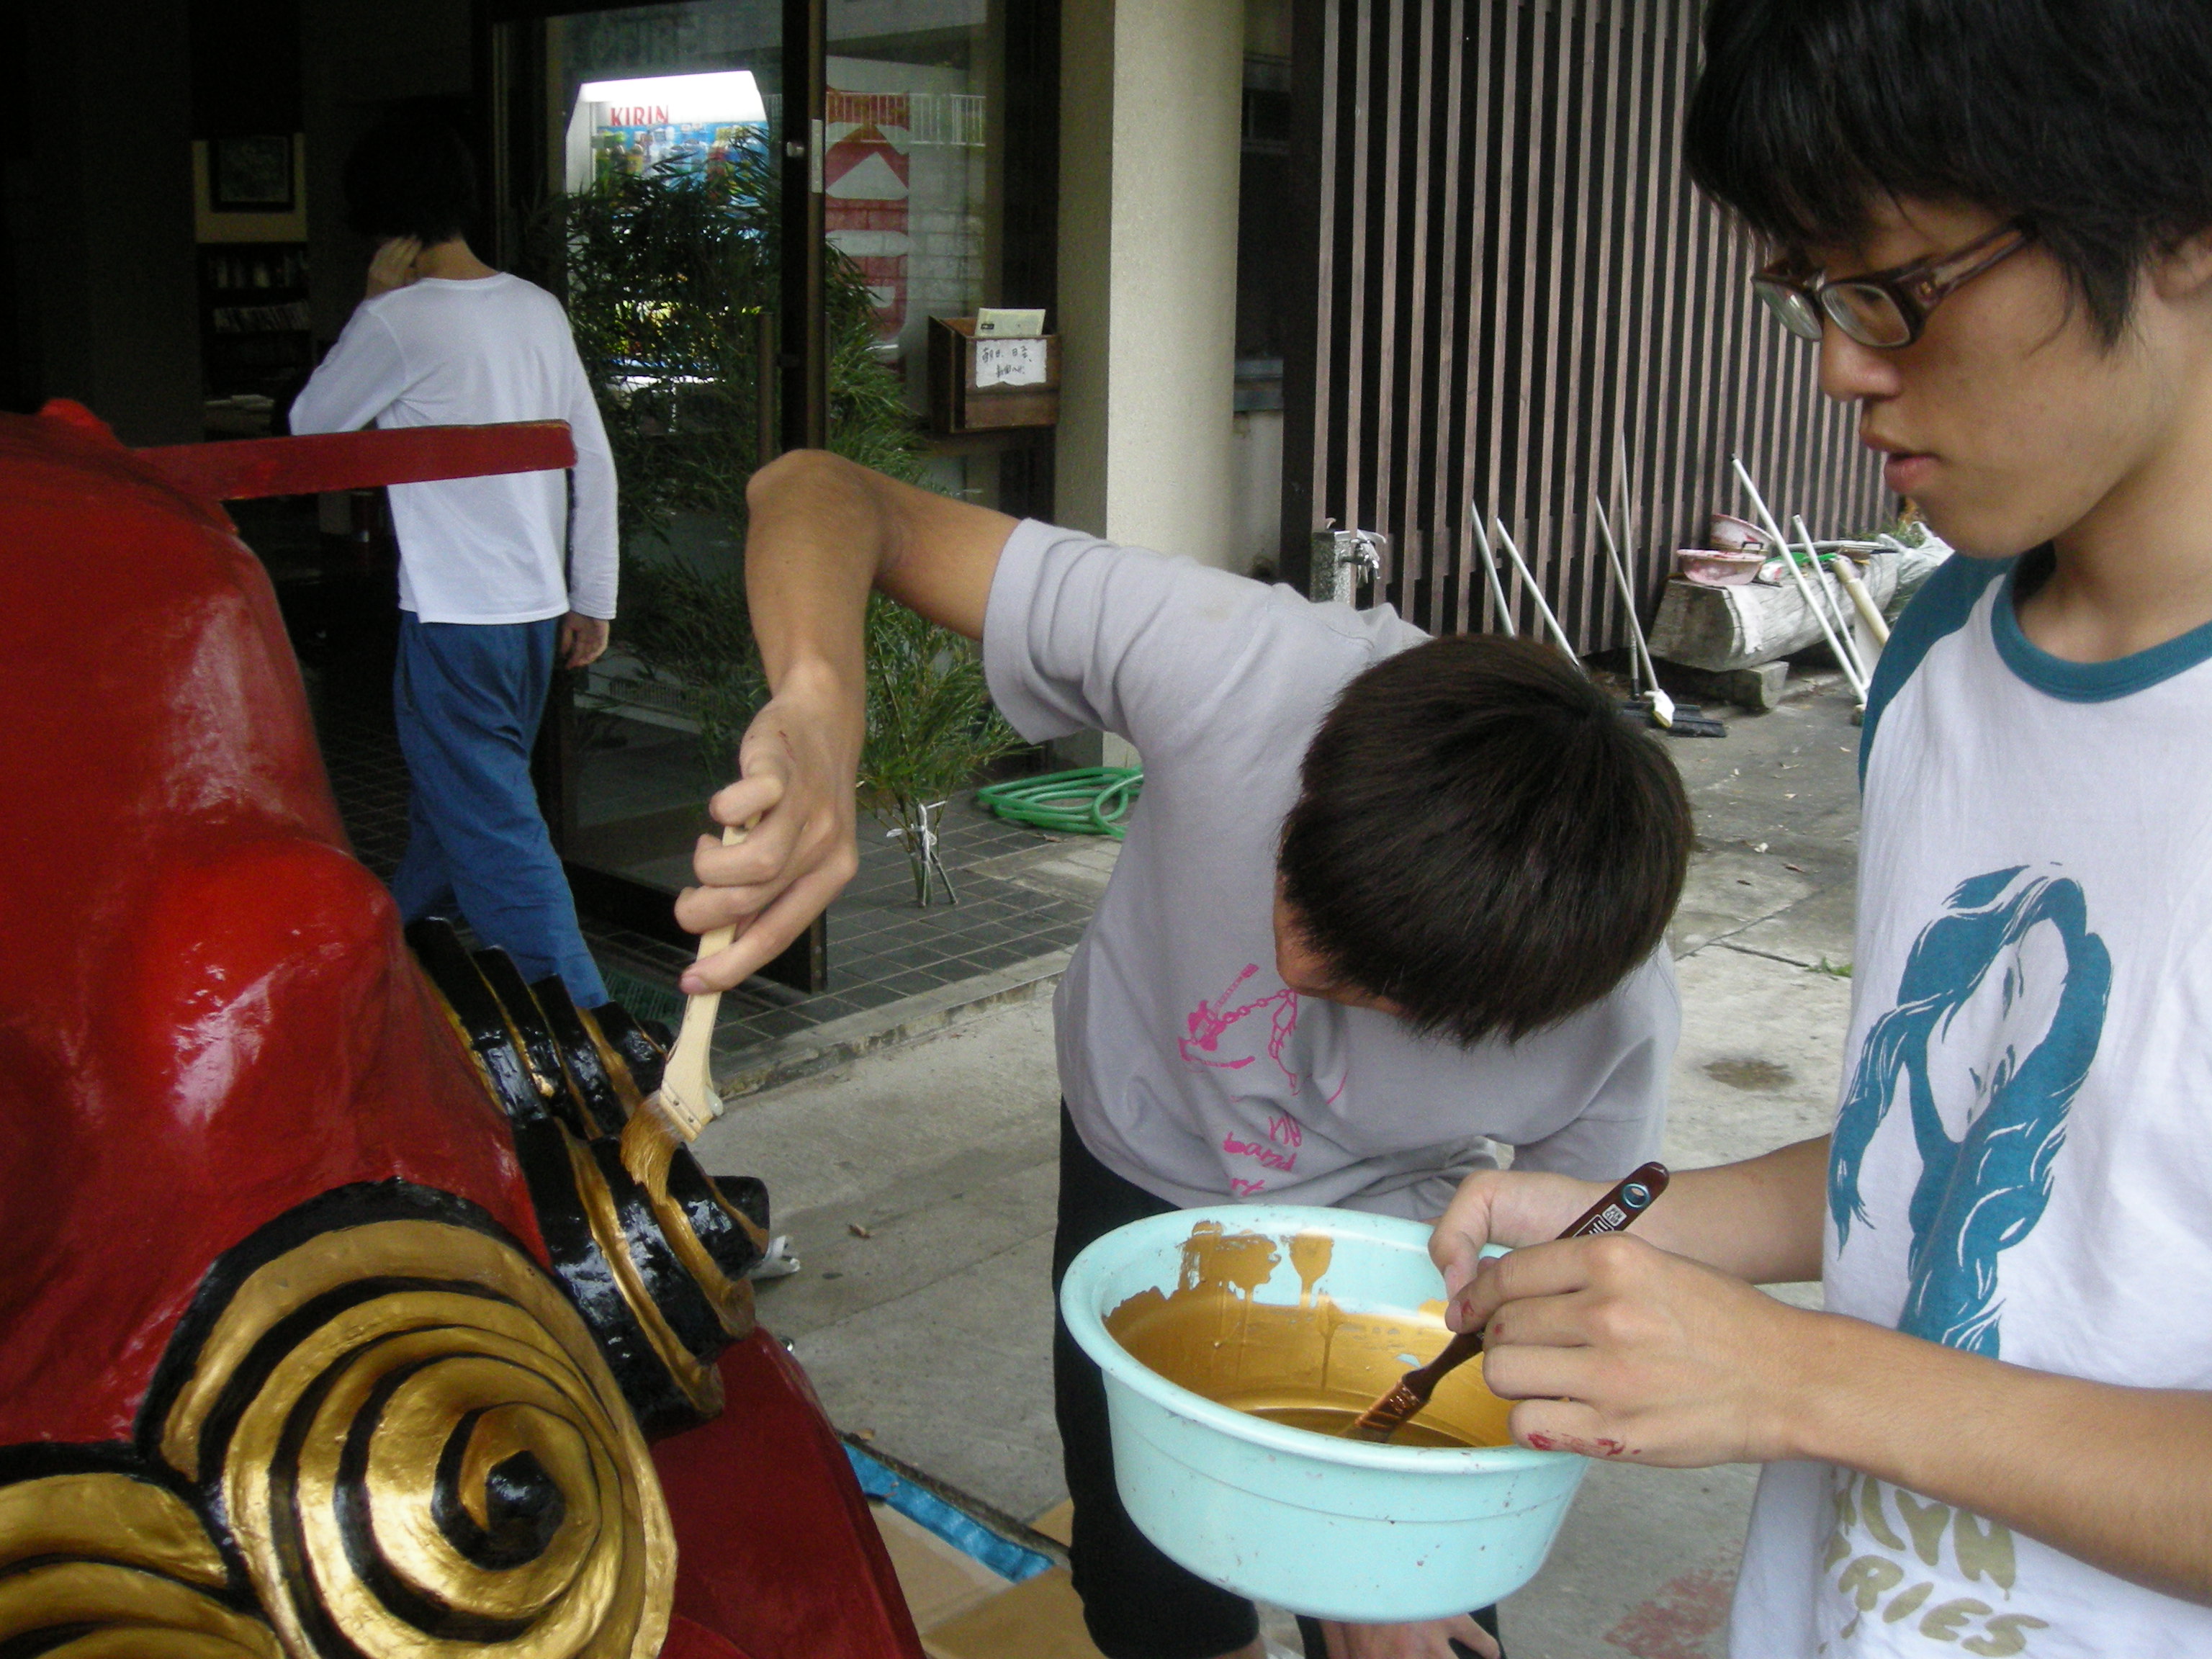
(491, 0, 825, 991)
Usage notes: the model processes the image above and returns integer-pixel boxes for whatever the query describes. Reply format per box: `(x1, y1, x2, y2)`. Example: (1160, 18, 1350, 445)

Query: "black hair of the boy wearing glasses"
(1683, 0, 2212, 345)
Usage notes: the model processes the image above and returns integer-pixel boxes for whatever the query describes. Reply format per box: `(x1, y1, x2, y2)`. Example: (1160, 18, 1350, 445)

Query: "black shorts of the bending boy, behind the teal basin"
(1053, 1106, 1498, 1659)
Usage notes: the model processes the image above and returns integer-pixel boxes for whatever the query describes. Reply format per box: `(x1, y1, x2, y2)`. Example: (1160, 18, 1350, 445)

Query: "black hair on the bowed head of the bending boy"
(1279, 635, 1690, 1044)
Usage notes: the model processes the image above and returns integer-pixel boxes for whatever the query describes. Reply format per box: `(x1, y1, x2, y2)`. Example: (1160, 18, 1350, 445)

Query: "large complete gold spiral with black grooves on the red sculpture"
(161, 1219, 675, 1659)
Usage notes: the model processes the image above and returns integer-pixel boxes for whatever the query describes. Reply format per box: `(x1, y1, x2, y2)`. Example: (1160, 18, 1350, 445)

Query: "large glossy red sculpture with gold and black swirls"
(0, 405, 920, 1659)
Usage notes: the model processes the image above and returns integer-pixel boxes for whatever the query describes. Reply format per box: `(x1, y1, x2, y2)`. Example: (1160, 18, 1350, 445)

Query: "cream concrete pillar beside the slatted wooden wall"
(1055, 0, 1243, 569)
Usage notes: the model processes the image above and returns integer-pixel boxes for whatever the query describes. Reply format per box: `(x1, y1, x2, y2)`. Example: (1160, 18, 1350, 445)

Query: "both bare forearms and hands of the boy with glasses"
(1431, 1141, 2212, 1604)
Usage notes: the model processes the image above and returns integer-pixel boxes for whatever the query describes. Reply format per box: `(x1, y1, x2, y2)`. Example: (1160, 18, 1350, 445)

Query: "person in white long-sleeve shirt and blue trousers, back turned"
(292, 124, 617, 1009)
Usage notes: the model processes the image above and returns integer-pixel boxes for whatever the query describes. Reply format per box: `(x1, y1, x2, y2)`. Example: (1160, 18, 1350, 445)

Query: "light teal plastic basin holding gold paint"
(1059, 1205, 1588, 1624)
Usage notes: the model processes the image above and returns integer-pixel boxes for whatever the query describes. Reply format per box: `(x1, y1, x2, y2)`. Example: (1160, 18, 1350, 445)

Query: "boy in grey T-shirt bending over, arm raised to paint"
(677, 454, 1690, 1659)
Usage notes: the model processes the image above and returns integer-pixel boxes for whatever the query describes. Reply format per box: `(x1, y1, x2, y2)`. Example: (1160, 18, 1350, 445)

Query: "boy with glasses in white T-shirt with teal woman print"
(1434, 0, 2212, 1659)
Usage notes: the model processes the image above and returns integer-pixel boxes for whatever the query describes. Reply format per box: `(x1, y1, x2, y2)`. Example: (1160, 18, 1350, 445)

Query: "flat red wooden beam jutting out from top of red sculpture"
(135, 421, 575, 502)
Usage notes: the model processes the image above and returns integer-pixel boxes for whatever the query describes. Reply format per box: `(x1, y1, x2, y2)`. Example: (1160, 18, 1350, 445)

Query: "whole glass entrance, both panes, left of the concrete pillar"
(487, 0, 1059, 991)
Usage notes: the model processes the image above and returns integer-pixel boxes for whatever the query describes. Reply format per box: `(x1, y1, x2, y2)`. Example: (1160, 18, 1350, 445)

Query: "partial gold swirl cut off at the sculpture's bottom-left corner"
(0, 1471, 283, 1659)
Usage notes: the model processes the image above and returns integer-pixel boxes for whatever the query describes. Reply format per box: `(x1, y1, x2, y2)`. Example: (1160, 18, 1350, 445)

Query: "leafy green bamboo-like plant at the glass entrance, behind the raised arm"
(540, 151, 1020, 904)
